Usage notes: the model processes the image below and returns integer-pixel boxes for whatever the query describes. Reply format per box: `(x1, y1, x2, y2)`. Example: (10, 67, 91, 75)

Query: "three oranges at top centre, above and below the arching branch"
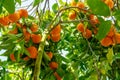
(68, 0, 85, 20)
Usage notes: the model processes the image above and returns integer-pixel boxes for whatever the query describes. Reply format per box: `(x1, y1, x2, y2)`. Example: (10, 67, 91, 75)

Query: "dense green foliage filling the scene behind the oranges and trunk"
(0, 0, 120, 80)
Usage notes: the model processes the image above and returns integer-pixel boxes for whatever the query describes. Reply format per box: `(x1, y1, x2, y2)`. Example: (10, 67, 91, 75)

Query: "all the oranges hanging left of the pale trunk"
(4, 9, 42, 61)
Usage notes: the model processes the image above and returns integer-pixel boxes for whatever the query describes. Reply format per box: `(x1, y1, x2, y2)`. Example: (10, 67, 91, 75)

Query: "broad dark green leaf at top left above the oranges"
(3, 0, 15, 13)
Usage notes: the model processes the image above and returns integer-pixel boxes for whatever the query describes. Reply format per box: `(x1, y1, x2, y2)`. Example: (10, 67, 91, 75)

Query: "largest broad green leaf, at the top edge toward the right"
(87, 0, 110, 16)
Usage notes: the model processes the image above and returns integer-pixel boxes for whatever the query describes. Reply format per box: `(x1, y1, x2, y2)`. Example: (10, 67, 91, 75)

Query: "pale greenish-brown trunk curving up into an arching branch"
(32, 7, 90, 80)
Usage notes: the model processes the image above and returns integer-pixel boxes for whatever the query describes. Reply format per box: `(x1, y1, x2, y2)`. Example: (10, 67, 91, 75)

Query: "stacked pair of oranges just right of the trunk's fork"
(48, 24, 61, 42)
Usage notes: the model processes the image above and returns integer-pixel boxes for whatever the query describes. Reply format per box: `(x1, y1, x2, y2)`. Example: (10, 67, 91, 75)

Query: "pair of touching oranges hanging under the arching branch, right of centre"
(77, 22, 92, 39)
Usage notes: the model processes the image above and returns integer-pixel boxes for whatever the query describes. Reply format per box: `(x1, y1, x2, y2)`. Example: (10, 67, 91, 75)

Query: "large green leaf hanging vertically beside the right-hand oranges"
(96, 21, 111, 40)
